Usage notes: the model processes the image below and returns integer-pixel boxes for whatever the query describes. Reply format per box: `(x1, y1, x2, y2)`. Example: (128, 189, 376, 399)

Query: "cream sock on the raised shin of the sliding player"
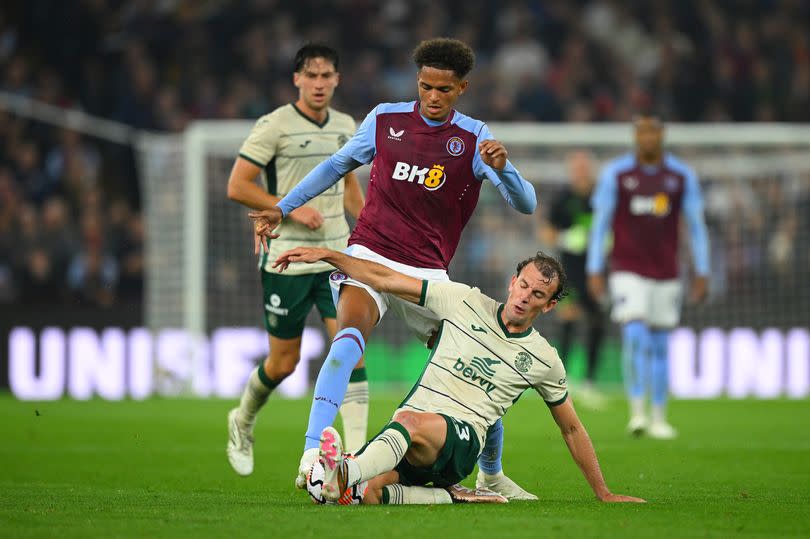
(346, 423, 411, 486)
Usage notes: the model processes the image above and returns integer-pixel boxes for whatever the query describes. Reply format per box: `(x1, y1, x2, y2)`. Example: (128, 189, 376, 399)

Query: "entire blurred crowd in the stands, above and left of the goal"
(0, 0, 810, 306)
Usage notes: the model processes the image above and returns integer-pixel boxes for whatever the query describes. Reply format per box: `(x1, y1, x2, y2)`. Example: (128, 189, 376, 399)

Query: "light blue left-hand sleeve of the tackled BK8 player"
(277, 107, 378, 217)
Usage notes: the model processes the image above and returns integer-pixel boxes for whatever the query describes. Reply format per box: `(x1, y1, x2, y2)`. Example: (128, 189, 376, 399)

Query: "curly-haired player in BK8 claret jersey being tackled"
(249, 38, 537, 498)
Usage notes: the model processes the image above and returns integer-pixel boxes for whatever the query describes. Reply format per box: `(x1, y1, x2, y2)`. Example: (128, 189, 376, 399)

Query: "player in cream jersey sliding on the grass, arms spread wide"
(276, 248, 644, 504)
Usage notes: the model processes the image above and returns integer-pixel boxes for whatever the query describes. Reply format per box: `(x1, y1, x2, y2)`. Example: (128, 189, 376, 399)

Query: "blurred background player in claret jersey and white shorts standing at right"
(587, 114, 709, 439)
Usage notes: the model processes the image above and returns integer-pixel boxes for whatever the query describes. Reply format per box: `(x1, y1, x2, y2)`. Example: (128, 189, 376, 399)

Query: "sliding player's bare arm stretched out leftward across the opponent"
(273, 247, 422, 303)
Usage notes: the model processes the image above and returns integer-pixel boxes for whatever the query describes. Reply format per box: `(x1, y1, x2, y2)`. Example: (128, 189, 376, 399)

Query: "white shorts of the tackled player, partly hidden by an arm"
(329, 244, 450, 342)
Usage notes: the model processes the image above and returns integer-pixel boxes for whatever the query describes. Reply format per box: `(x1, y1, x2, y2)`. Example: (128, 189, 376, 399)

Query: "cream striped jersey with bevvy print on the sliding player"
(400, 281, 567, 448)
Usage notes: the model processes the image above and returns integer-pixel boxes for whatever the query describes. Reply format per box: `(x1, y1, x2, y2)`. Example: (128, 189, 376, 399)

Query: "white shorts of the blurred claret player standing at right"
(608, 271, 683, 329)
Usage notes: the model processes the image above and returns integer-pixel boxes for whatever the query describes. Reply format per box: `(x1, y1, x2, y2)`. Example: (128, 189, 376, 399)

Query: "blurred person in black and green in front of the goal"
(540, 150, 605, 408)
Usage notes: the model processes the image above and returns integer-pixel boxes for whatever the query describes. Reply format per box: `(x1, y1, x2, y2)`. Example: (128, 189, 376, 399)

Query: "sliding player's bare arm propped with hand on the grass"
(551, 399, 645, 502)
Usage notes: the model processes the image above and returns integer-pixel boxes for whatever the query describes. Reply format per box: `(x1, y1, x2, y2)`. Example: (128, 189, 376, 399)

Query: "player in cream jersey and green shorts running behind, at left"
(227, 44, 368, 475)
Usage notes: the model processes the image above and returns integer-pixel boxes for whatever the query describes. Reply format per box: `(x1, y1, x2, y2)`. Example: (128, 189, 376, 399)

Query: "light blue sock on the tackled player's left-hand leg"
(304, 328, 366, 450)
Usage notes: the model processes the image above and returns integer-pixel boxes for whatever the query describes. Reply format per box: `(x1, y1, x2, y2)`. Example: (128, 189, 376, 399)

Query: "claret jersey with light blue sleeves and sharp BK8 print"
(279, 101, 537, 269)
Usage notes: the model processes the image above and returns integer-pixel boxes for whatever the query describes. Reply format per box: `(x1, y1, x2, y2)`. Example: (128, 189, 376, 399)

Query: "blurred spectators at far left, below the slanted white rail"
(0, 119, 143, 307)
